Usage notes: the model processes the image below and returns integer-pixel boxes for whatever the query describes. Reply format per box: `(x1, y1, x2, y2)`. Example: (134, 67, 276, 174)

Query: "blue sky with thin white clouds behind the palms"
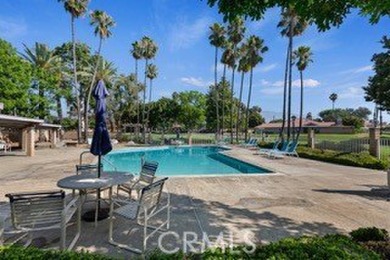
(0, 0, 390, 122)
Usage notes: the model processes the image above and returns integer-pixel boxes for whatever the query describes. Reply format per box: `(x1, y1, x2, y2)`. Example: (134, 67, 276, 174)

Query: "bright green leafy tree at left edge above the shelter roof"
(0, 39, 32, 116)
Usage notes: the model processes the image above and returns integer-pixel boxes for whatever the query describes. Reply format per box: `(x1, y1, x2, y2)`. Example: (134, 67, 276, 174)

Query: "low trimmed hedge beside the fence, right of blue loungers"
(297, 147, 389, 170)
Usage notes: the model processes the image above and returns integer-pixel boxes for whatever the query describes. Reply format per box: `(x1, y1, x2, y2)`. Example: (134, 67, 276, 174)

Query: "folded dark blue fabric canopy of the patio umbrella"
(90, 80, 112, 156)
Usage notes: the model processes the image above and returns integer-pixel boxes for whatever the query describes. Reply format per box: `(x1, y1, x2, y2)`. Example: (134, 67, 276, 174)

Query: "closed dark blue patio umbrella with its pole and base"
(83, 80, 112, 221)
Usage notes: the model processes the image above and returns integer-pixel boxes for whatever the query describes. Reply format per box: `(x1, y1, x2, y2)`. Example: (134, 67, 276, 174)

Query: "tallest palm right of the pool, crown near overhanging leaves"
(278, 5, 307, 140)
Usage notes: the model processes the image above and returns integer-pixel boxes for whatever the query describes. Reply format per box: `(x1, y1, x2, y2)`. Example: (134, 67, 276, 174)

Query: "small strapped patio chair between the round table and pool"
(117, 161, 158, 197)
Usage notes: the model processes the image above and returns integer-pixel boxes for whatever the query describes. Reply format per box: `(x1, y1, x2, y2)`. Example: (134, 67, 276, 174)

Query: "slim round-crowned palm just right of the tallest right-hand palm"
(293, 46, 313, 141)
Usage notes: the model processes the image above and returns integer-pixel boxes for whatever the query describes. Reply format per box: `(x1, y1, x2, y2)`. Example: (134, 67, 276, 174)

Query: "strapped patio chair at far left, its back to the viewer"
(0, 190, 81, 249)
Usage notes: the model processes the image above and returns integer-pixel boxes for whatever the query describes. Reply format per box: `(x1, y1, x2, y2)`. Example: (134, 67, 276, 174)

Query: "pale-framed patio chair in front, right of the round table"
(108, 178, 170, 254)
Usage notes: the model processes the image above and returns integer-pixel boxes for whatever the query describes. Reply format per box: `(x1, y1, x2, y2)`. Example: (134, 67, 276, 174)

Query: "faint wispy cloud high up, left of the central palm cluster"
(168, 17, 212, 50)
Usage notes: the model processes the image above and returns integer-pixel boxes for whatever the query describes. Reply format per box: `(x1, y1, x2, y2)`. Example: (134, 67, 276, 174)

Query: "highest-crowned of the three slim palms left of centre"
(140, 36, 158, 142)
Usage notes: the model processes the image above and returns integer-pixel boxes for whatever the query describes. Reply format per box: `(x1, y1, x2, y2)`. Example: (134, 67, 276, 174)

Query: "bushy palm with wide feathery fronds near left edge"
(21, 42, 61, 117)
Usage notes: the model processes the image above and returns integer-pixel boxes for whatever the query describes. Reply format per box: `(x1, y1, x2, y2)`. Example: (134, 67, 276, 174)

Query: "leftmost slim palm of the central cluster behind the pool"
(209, 23, 226, 140)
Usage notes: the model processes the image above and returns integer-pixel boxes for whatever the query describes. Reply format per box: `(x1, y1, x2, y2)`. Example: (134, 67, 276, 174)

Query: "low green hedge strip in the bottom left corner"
(0, 246, 114, 260)
